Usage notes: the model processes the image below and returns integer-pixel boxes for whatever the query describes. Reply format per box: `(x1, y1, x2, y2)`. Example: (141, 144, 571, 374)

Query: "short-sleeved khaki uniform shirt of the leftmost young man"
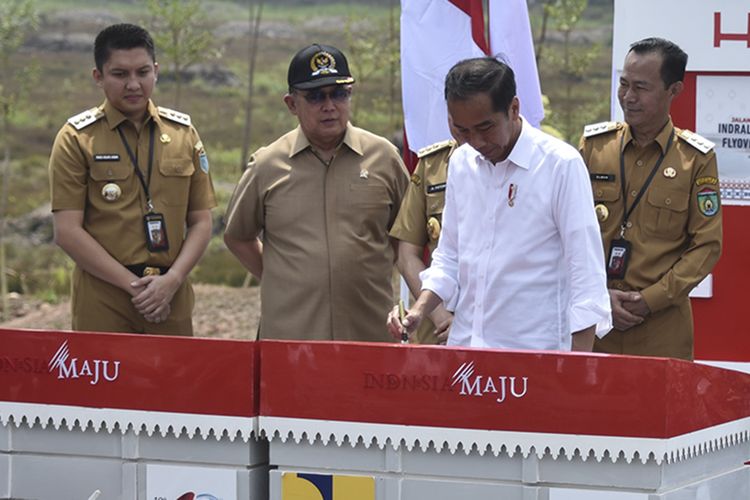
(49, 102, 216, 266)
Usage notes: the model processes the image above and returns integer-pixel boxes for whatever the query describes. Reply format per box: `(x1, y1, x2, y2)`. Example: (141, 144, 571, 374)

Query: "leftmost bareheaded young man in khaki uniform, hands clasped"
(49, 24, 216, 335)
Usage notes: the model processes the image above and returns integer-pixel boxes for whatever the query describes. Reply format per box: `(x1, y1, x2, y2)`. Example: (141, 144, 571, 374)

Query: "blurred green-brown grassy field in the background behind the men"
(0, 0, 612, 316)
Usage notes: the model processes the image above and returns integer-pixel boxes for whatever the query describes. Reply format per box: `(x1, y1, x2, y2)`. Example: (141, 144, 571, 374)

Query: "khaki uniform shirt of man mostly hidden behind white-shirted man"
(391, 140, 457, 344)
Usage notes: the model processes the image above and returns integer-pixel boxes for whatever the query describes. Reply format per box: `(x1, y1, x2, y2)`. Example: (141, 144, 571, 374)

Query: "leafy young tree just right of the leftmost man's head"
(146, 0, 212, 107)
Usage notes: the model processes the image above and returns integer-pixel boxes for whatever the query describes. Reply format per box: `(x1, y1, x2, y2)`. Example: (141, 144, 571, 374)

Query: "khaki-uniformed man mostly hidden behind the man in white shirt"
(391, 140, 457, 344)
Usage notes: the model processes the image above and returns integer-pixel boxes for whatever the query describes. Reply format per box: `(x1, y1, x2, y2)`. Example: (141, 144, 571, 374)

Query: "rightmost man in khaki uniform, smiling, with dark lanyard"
(580, 38, 721, 359)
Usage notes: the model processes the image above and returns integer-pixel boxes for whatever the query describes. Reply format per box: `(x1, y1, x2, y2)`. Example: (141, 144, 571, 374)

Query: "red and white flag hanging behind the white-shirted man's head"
(401, 0, 544, 156)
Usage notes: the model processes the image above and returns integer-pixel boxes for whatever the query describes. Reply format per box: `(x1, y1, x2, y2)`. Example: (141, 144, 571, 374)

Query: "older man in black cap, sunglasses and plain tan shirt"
(224, 44, 408, 342)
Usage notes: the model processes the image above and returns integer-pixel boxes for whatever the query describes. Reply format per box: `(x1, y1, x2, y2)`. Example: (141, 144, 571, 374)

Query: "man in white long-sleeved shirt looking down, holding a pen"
(388, 57, 612, 351)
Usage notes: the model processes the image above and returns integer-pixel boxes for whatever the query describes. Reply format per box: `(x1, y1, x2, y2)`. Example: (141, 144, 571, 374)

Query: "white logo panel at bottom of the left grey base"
(146, 464, 237, 500)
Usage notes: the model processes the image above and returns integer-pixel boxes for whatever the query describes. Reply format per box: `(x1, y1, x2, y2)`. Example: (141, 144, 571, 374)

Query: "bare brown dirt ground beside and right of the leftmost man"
(0, 284, 260, 339)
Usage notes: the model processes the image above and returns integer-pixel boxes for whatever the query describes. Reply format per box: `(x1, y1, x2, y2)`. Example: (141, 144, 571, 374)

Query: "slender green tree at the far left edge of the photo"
(0, 0, 38, 318)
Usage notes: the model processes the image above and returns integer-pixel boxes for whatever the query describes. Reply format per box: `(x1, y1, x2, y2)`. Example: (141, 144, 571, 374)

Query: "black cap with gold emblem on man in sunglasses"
(287, 43, 354, 90)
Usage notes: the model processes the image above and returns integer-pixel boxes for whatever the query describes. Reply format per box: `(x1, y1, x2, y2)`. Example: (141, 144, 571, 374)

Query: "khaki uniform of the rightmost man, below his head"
(580, 120, 721, 359)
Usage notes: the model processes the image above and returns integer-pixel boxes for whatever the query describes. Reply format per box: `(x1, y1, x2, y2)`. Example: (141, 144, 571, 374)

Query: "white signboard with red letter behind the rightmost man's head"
(612, 0, 750, 72)
